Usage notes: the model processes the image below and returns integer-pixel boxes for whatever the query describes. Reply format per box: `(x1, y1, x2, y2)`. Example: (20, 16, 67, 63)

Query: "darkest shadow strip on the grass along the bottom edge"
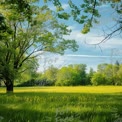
(0, 106, 122, 122)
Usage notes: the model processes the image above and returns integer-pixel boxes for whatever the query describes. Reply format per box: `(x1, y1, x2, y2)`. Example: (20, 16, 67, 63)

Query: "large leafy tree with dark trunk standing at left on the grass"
(0, 0, 78, 92)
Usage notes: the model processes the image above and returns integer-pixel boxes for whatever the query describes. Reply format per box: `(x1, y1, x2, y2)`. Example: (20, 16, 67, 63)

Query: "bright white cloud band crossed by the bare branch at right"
(69, 27, 122, 49)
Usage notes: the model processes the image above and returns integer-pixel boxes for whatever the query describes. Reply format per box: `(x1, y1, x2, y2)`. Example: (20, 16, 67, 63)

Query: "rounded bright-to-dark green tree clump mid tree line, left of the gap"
(56, 64, 86, 86)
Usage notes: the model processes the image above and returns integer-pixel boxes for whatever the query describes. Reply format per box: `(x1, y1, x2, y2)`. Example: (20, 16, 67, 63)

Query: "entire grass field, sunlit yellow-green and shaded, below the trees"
(0, 86, 122, 122)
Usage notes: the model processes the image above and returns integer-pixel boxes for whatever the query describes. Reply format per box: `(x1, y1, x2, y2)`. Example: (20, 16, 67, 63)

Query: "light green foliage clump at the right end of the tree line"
(91, 64, 122, 85)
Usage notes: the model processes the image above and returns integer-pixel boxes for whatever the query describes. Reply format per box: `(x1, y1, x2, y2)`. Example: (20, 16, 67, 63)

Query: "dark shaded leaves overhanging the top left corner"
(0, 0, 32, 40)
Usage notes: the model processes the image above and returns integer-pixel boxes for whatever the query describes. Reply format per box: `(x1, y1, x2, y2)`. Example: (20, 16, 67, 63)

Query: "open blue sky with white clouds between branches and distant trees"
(38, 0, 122, 71)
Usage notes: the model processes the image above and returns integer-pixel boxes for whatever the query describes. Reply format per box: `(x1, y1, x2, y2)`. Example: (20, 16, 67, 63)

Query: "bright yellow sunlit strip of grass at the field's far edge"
(0, 86, 122, 93)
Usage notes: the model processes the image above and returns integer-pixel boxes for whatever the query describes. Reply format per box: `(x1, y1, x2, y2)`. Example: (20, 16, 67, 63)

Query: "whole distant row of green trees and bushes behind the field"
(15, 63, 122, 86)
